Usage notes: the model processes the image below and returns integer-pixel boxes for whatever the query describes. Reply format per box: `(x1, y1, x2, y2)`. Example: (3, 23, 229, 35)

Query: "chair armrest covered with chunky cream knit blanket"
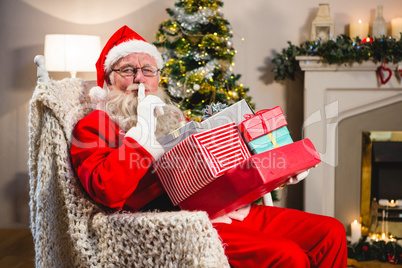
(93, 211, 229, 268)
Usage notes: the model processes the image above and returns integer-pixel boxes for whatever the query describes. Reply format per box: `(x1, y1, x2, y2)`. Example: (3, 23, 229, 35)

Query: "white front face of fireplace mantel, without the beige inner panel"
(296, 56, 402, 216)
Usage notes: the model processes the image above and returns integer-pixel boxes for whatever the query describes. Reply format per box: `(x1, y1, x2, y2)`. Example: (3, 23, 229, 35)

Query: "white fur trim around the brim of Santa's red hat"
(103, 40, 163, 72)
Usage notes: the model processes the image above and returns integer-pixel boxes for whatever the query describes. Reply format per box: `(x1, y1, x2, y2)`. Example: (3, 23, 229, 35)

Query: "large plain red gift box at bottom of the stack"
(180, 139, 321, 219)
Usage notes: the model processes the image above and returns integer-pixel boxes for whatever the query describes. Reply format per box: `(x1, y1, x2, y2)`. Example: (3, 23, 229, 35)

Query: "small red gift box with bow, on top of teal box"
(238, 106, 288, 142)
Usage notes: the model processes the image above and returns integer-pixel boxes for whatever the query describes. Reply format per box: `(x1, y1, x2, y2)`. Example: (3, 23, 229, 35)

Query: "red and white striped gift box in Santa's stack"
(154, 123, 251, 206)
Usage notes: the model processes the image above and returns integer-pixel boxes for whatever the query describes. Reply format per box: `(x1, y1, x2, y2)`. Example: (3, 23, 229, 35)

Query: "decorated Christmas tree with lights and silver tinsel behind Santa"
(154, 0, 253, 121)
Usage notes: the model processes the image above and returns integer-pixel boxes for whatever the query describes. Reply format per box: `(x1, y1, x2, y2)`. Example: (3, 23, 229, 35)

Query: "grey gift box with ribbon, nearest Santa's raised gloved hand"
(158, 121, 207, 152)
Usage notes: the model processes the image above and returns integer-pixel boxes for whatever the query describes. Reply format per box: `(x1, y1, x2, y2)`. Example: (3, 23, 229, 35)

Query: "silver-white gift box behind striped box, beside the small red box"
(201, 99, 254, 129)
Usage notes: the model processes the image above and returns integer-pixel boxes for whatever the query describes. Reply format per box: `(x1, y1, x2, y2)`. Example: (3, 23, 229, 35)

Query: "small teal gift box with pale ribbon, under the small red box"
(247, 127, 293, 154)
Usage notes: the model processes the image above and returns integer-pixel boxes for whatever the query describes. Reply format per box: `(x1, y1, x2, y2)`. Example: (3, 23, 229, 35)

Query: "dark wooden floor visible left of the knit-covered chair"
(0, 229, 35, 268)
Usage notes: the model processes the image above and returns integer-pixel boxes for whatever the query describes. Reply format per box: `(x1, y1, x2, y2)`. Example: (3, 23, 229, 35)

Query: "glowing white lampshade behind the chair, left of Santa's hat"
(45, 34, 100, 77)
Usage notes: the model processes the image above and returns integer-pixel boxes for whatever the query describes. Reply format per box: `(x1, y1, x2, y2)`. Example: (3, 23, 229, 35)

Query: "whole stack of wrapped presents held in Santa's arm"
(154, 100, 321, 219)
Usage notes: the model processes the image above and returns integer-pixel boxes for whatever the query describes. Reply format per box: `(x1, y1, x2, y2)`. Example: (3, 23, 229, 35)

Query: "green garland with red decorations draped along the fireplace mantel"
(272, 33, 402, 81)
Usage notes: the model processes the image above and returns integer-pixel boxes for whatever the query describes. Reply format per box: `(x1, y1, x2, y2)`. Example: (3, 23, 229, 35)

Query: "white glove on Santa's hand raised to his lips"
(126, 84, 165, 160)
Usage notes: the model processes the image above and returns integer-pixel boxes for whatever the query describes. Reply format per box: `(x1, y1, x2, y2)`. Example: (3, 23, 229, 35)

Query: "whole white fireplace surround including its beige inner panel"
(297, 57, 402, 230)
